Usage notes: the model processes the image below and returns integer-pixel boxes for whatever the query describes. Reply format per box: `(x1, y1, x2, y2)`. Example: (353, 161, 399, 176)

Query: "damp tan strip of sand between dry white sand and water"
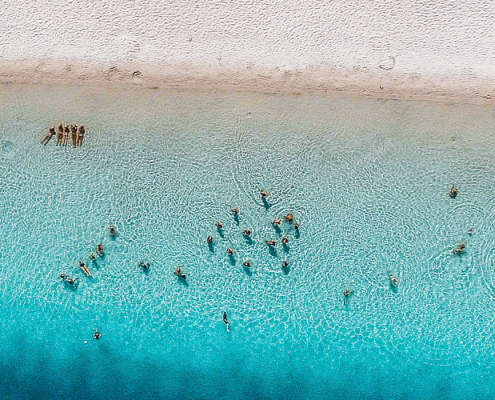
(0, 59, 495, 105)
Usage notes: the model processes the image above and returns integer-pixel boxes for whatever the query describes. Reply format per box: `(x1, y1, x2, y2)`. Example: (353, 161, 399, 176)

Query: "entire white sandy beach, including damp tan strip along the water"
(0, 0, 495, 103)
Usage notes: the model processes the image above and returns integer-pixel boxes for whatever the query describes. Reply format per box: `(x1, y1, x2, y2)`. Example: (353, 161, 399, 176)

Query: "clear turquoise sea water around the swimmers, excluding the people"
(0, 85, 495, 399)
